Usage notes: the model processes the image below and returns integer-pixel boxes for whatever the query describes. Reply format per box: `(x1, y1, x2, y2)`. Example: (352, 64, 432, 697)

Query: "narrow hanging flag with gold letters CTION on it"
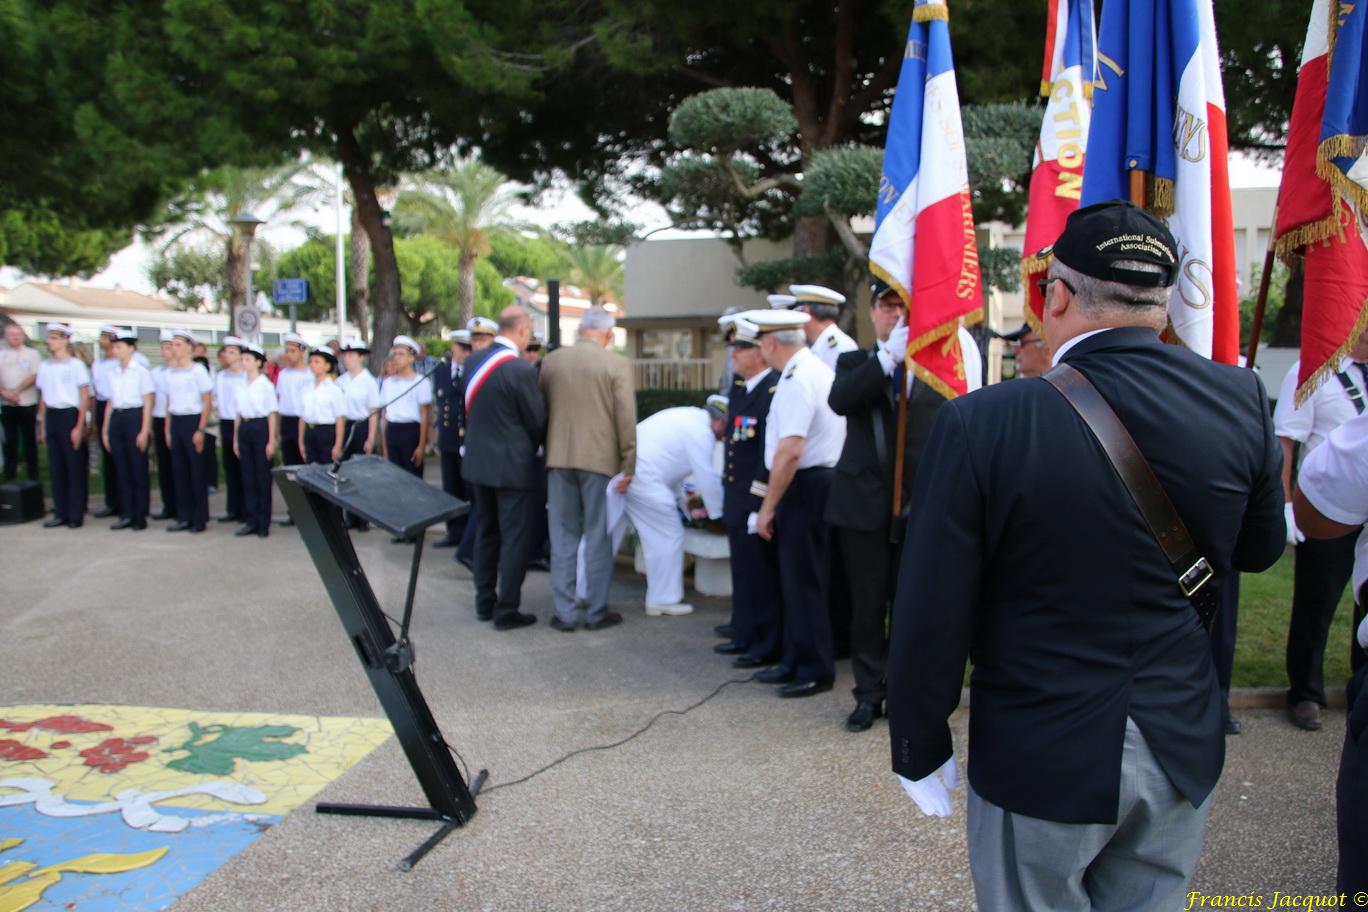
(1022, 0, 1097, 332)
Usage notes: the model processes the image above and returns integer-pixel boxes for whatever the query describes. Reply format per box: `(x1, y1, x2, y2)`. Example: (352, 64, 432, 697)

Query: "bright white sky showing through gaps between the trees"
(0, 153, 1280, 294)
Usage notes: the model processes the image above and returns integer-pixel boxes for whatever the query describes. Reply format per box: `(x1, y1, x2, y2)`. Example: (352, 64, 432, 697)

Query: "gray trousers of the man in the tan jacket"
(546, 469, 613, 623)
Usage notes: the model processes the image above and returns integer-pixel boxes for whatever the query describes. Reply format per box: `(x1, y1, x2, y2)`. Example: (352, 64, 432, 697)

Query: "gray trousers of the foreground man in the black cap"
(969, 718, 1211, 912)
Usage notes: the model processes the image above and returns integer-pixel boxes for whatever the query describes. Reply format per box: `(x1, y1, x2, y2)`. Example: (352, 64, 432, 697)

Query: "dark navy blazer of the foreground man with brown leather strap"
(888, 328, 1285, 823)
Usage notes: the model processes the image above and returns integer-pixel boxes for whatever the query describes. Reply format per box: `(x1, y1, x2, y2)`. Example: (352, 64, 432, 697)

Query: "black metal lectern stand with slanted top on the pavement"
(275, 455, 488, 871)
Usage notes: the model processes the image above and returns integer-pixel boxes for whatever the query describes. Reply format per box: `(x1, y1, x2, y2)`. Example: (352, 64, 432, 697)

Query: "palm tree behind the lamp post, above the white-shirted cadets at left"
(146, 160, 326, 332)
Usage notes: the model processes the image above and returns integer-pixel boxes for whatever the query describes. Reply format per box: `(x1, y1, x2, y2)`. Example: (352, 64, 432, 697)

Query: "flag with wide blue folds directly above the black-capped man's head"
(1082, 0, 1239, 364)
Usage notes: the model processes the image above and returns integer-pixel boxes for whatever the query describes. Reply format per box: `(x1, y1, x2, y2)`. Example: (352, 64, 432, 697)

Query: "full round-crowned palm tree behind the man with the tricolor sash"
(394, 157, 518, 325)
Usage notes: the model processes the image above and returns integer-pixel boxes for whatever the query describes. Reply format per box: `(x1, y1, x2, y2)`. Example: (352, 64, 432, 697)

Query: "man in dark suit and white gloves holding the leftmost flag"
(826, 282, 945, 732)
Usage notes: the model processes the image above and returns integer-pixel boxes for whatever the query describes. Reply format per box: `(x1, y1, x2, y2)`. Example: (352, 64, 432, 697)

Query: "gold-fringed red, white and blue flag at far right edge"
(1276, 0, 1368, 403)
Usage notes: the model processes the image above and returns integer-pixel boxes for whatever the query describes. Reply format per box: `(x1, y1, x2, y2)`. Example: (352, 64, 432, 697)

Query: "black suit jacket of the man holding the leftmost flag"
(826, 349, 945, 532)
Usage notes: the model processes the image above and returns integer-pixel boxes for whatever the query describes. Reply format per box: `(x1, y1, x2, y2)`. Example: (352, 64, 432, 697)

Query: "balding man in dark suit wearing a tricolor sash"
(461, 305, 546, 630)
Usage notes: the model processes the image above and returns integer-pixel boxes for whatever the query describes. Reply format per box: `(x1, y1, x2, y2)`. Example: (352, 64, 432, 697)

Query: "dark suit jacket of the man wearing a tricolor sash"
(461, 345, 546, 491)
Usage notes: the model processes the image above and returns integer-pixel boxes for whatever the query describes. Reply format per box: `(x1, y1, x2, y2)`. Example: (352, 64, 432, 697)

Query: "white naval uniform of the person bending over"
(593, 407, 722, 606)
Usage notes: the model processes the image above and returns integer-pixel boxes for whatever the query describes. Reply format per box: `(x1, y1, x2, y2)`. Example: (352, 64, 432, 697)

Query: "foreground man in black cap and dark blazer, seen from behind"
(888, 201, 1285, 909)
